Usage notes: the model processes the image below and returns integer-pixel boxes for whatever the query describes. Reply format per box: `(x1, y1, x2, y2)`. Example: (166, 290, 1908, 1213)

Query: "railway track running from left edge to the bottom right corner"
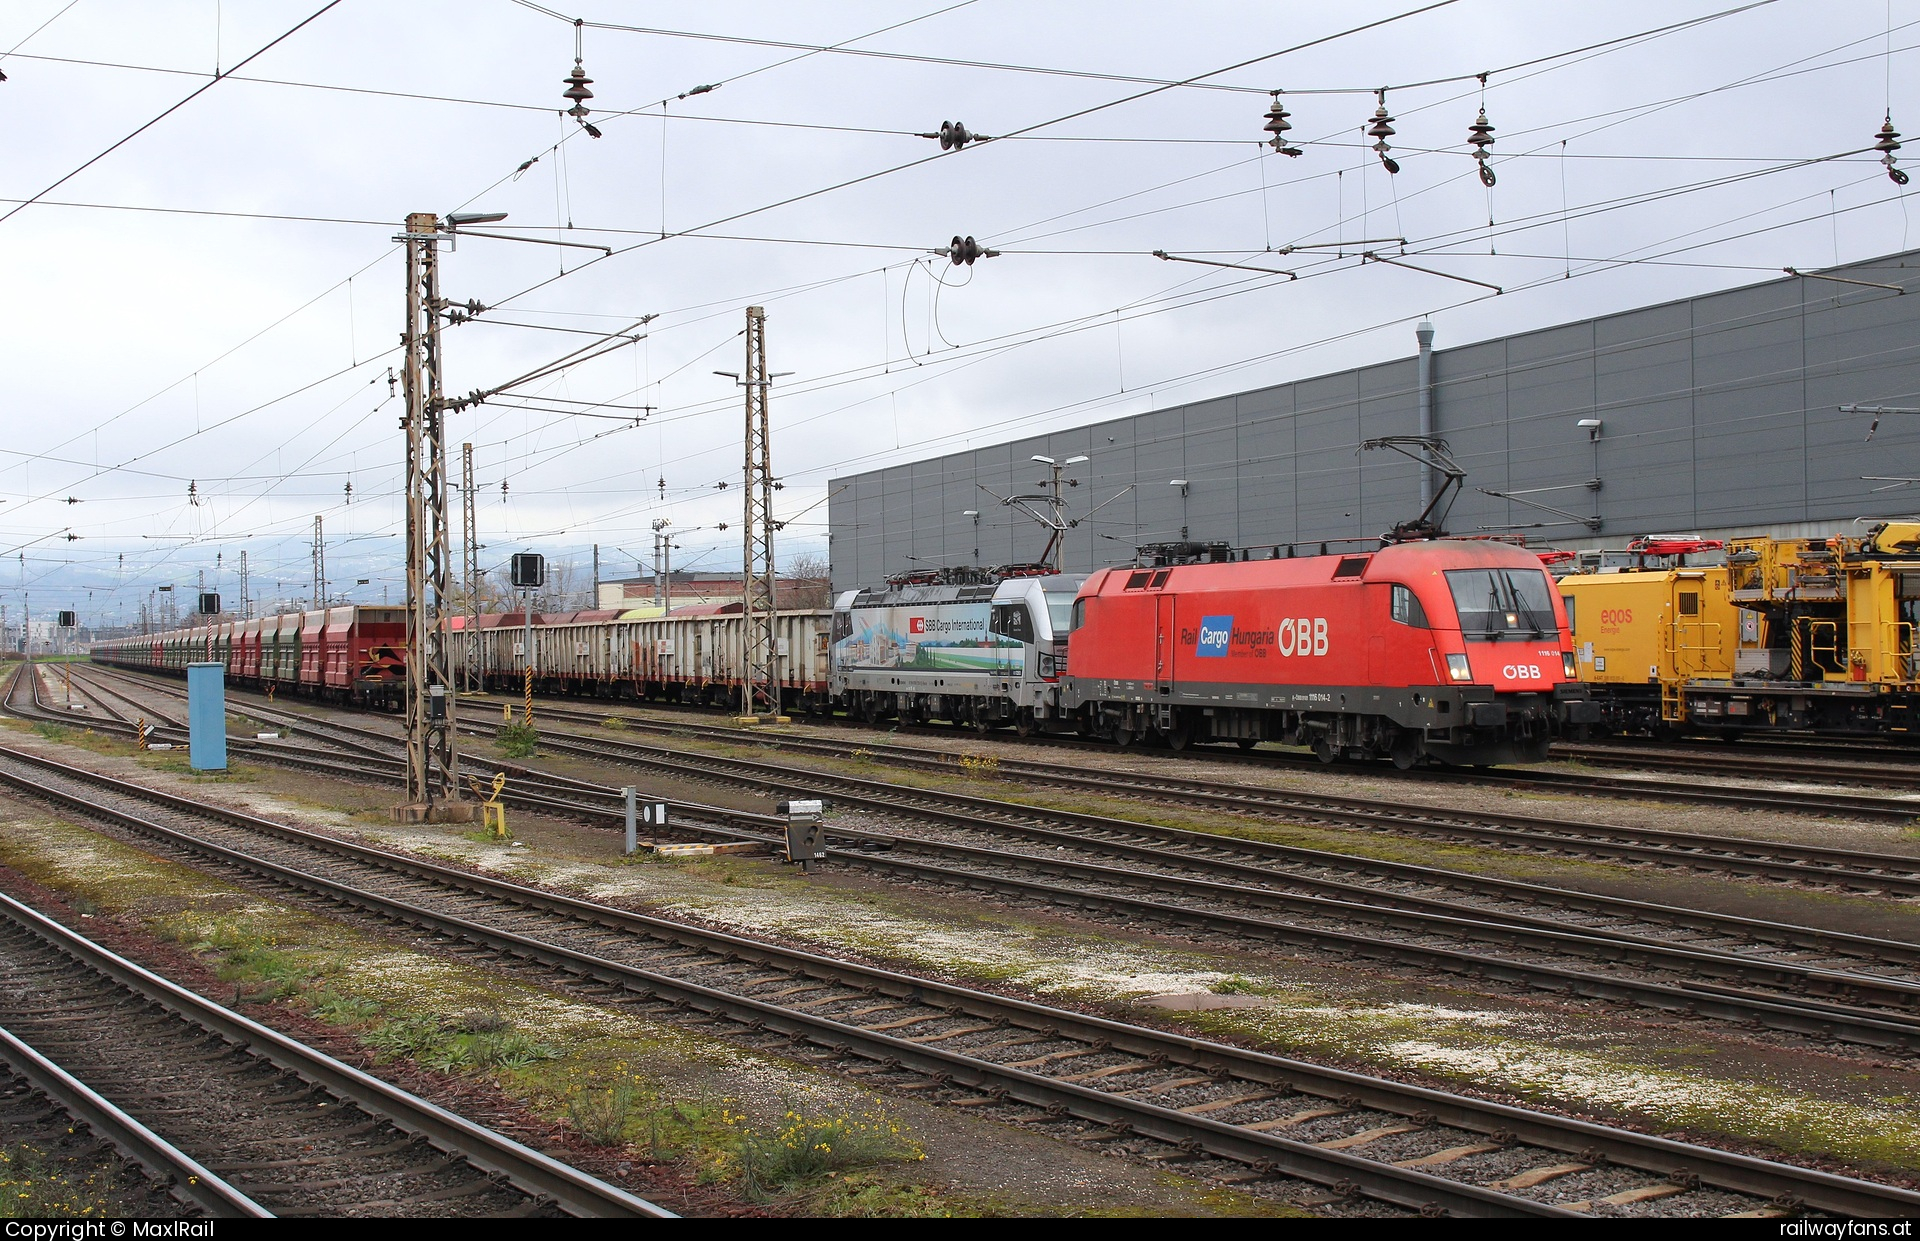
(0, 755, 1920, 1216)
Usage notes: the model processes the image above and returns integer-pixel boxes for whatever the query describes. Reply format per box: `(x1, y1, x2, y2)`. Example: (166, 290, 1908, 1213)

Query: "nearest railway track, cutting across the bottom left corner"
(0, 883, 670, 1218)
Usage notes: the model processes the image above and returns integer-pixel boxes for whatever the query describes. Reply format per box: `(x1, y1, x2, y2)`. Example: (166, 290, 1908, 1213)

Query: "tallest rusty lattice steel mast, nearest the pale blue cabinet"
(399, 211, 465, 818)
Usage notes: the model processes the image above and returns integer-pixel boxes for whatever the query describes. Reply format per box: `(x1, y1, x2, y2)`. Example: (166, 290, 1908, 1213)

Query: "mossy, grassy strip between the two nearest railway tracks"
(0, 807, 1273, 1216)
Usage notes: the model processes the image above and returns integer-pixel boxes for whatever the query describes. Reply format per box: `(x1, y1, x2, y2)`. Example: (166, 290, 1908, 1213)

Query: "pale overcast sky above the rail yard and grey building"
(0, 0, 1920, 622)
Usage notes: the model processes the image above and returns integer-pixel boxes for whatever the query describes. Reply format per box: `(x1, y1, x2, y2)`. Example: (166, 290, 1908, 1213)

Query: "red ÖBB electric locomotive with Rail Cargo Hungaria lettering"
(1062, 538, 1597, 768)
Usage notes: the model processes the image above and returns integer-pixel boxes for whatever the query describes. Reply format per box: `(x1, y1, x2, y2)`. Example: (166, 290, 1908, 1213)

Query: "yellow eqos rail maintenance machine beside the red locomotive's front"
(1559, 521, 1920, 736)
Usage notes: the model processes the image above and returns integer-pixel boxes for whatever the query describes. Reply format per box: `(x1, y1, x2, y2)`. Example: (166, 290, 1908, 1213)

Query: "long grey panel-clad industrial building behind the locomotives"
(828, 252, 1920, 588)
